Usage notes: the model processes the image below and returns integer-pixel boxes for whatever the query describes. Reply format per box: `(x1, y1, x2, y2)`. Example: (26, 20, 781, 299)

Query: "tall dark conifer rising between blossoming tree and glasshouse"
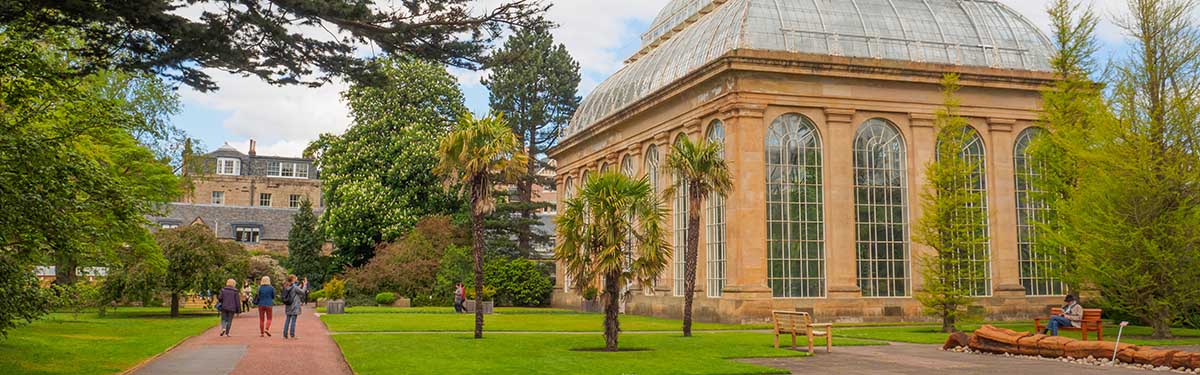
(482, 25, 580, 257)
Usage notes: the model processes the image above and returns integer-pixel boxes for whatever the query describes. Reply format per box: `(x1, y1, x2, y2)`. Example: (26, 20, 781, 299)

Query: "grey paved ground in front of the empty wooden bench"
(738, 344, 1147, 375)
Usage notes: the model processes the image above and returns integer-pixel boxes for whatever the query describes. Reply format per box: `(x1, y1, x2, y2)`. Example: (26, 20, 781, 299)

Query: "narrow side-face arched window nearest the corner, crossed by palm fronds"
(704, 120, 726, 297)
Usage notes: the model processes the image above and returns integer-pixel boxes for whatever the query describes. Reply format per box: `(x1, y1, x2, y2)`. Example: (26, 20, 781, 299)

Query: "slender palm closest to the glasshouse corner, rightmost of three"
(662, 137, 733, 337)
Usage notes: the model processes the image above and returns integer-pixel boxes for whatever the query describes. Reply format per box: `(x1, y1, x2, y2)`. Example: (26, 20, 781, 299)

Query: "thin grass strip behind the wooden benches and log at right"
(833, 321, 1200, 346)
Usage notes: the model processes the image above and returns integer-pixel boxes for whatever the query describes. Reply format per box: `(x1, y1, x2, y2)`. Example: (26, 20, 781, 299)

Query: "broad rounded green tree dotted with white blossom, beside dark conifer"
(305, 56, 468, 267)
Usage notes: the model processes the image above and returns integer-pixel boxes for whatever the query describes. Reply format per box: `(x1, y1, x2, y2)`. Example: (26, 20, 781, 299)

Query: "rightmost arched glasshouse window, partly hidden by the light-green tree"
(1013, 127, 1067, 296)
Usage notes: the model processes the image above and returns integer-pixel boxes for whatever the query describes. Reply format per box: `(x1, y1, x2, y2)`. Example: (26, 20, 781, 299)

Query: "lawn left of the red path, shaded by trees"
(0, 308, 217, 374)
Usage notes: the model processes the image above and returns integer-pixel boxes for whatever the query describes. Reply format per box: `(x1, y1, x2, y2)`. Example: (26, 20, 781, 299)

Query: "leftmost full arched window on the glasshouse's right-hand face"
(766, 113, 826, 297)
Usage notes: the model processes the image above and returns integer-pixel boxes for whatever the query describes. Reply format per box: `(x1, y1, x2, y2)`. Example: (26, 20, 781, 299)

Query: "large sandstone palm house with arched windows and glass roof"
(550, 0, 1066, 322)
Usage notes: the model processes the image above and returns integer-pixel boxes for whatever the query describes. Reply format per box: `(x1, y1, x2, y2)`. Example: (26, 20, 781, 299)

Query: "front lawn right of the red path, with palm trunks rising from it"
(334, 332, 883, 375)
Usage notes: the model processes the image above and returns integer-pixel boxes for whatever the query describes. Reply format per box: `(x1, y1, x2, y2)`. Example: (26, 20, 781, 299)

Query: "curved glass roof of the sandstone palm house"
(563, 0, 1054, 137)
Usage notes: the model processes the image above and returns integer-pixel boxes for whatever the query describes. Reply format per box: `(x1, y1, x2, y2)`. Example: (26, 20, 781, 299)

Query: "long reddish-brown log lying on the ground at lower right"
(942, 326, 1200, 369)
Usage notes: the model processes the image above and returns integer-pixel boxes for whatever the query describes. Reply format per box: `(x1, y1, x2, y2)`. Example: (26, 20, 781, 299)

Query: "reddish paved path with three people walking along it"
(133, 306, 352, 375)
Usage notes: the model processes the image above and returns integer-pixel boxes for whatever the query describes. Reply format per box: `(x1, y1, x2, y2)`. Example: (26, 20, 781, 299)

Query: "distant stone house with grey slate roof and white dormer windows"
(151, 141, 330, 255)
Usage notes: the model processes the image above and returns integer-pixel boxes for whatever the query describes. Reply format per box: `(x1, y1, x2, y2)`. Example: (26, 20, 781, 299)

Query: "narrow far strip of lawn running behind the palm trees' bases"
(320, 309, 769, 332)
